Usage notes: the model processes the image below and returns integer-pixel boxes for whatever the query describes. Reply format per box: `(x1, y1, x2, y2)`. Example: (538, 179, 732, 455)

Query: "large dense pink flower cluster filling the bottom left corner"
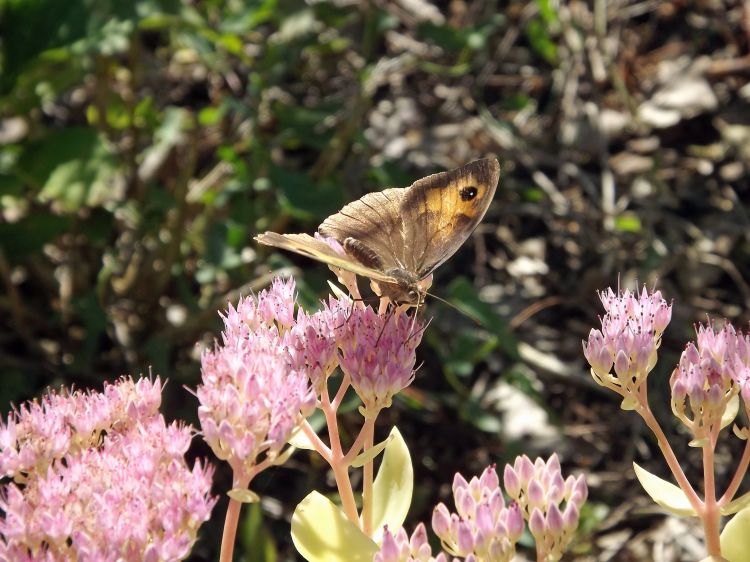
(0, 378, 215, 562)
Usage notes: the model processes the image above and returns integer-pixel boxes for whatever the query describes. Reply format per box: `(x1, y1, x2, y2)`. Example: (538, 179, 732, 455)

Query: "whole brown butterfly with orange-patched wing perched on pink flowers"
(255, 158, 500, 306)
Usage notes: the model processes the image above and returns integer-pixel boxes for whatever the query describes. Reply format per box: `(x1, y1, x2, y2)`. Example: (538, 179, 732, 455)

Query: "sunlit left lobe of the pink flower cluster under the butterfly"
(196, 279, 318, 483)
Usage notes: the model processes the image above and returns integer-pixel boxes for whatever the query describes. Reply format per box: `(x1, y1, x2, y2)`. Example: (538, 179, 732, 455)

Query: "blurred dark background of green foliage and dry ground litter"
(0, 0, 750, 562)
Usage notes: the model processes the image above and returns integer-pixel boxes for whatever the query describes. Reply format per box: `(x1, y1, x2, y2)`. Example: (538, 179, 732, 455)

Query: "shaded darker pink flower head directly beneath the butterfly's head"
(337, 306, 423, 414)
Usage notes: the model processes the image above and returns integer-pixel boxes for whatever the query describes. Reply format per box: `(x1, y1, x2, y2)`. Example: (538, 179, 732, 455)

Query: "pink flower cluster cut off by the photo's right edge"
(670, 324, 750, 438)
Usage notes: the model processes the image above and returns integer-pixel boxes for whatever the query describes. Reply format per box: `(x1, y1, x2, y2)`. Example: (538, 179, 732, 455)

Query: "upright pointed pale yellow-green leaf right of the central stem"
(372, 427, 414, 541)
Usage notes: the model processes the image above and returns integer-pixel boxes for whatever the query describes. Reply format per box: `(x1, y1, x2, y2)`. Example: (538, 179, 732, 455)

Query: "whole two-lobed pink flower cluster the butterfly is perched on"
(196, 279, 422, 481)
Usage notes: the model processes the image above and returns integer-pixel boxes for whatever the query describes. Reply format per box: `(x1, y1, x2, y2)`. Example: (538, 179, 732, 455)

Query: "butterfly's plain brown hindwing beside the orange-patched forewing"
(318, 188, 406, 271)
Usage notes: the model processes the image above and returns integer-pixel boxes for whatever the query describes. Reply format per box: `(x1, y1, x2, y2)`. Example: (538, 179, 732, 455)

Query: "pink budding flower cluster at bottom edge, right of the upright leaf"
(373, 455, 588, 562)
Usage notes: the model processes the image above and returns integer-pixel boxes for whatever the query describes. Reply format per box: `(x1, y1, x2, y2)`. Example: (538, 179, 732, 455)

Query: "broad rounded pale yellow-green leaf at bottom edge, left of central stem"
(292, 491, 378, 562)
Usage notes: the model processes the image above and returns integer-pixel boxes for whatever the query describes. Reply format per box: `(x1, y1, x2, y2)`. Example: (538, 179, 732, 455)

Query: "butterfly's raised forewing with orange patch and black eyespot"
(400, 158, 500, 278)
